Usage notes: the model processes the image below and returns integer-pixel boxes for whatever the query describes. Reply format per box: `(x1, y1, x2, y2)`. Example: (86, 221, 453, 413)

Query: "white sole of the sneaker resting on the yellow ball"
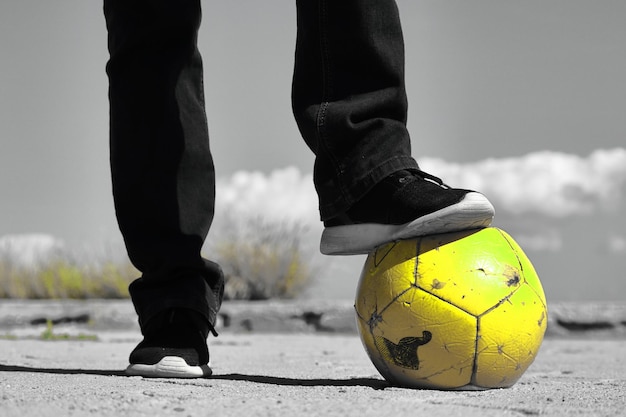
(320, 192, 494, 255)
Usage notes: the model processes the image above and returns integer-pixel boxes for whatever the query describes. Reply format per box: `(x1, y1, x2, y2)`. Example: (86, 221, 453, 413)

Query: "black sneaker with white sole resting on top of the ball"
(320, 171, 494, 255)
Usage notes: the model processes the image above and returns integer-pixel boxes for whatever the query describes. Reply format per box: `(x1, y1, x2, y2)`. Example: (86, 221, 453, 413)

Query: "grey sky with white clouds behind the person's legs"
(0, 0, 626, 300)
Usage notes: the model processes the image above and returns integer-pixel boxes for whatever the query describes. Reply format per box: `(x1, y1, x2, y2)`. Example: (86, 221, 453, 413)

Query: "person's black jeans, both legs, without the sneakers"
(104, 0, 417, 332)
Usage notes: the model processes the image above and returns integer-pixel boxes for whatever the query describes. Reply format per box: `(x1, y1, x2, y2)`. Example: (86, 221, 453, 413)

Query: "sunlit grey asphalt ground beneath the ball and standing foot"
(0, 302, 626, 417)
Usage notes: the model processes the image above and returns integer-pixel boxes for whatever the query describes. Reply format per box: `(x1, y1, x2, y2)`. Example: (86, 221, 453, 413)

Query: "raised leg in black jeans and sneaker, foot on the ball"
(292, 0, 493, 254)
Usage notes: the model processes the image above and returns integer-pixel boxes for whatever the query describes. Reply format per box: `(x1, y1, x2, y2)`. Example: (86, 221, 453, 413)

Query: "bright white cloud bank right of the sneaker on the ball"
(419, 148, 626, 217)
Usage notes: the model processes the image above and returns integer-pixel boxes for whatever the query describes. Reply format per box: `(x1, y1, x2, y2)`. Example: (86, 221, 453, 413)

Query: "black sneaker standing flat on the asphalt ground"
(126, 308, 212, 378)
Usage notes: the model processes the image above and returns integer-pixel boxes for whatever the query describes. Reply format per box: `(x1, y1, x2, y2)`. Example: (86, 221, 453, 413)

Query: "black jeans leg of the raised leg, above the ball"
(292, 0, 417, 220)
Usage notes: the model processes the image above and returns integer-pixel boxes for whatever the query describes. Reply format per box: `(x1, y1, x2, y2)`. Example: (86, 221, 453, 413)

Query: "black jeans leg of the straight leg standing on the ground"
(104, 0, 223, 332)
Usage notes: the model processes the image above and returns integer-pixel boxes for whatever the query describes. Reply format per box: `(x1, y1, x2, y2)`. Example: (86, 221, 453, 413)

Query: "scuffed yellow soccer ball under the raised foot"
(355, 227, 547, 389)
